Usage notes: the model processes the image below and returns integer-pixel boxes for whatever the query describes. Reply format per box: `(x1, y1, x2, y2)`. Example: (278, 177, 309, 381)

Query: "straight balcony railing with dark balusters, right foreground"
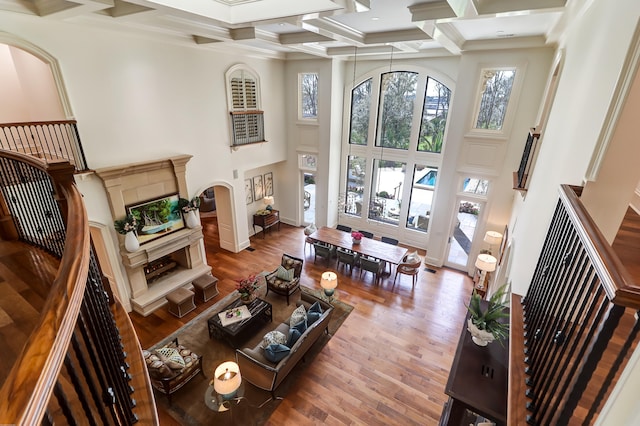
(508, 185, 640, 425)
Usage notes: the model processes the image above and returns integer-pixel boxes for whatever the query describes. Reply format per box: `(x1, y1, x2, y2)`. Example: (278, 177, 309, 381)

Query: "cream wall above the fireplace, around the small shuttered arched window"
(0, 13, 287, 256)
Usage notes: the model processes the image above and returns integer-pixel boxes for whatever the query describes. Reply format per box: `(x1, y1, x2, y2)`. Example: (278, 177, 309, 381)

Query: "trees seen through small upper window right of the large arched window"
(475, 69, 516, 130)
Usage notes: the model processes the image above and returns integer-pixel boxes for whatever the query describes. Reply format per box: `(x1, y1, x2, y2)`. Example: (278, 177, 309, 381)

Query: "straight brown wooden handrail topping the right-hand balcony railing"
(560, 185, 640, 309)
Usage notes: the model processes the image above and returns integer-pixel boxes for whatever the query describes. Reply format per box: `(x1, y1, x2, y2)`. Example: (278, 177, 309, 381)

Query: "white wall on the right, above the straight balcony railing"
(510, 0, 640, 294)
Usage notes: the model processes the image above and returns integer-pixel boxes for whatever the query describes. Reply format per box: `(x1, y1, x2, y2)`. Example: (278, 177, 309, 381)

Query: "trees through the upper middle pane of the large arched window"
(376, 71, 418, 150)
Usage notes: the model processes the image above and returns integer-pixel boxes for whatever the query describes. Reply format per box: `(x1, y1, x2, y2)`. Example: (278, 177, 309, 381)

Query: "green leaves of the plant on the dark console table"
(467, 284, 509, 340)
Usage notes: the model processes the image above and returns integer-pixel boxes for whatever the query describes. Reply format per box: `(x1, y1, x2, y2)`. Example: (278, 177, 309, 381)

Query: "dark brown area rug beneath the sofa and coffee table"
(150, 286, 353, 426)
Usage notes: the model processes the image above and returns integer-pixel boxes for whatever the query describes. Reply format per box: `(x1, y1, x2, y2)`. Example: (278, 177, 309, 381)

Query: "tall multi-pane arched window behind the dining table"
(343, 70, 451, 232)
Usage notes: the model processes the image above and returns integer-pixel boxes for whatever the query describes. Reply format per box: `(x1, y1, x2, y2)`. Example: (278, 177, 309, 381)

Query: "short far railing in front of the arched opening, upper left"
(0, 120, 89, 171)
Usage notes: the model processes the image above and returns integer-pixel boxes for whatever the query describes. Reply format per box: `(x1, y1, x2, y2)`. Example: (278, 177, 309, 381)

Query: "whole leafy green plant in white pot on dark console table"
(467, 284, 509, 346)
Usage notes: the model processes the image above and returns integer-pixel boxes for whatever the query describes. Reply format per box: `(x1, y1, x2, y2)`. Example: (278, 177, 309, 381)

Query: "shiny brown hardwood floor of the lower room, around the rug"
(131, 218, 472, 425)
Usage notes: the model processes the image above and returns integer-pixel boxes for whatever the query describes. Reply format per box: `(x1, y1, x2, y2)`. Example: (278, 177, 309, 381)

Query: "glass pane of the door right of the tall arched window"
(445, 198, 484, 271)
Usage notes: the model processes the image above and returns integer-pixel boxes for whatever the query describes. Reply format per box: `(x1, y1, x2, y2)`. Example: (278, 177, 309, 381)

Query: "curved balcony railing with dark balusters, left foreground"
(0, 151, 157, 425)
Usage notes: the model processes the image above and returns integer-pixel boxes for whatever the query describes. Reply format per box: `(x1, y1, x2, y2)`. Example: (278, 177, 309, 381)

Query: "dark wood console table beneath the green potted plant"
(440, 300, 509, 426)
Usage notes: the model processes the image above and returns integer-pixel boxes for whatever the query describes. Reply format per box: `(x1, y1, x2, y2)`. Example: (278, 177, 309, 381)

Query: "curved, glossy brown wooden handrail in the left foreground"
(0, 155, 90, 424)
